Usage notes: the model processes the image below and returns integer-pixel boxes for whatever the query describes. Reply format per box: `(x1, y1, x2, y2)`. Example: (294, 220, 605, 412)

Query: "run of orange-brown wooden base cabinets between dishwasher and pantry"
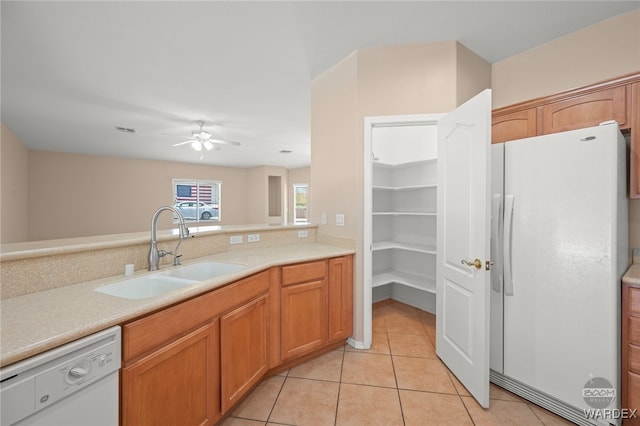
(120, 256, 353, 426)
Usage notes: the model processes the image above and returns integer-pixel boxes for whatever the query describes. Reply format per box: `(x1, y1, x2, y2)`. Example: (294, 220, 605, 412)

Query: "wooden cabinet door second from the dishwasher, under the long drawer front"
(220, 294, 269, 413)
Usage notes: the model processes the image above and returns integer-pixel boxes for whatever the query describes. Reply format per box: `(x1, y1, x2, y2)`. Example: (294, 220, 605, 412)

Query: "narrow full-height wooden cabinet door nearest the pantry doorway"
(329, 256, 353, 340)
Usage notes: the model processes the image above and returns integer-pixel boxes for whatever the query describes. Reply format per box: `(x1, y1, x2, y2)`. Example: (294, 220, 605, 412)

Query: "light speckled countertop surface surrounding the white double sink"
(0, 243, 354, 366)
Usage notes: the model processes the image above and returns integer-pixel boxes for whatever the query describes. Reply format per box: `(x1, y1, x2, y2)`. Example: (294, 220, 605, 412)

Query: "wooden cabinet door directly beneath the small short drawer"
(280, 279, 328, 360)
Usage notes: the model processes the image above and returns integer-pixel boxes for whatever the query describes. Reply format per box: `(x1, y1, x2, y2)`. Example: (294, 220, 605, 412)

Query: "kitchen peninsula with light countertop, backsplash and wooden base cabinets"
(0, 227, 354, 426)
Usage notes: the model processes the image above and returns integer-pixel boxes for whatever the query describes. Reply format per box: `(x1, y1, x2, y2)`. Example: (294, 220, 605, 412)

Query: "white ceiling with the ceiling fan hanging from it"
(0, 0, 640, 168)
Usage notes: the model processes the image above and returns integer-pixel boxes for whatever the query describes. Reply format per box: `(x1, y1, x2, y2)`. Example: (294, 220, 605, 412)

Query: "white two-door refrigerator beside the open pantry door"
(490, 124, 629, 424)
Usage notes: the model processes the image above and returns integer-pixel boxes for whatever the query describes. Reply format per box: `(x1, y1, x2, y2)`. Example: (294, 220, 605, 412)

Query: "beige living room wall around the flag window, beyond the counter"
(0, 125, 302, 243)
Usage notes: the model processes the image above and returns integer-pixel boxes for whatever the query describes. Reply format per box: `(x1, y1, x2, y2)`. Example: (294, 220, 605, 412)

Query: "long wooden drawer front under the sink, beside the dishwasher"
(122, 271, 269, 363)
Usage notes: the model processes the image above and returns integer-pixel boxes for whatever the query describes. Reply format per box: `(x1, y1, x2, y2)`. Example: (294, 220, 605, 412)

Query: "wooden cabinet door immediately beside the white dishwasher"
(121, 322, 220, 426)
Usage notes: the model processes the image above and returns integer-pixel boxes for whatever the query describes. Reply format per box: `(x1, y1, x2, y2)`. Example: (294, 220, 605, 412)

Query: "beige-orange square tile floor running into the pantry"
(222, 301, 572, 426)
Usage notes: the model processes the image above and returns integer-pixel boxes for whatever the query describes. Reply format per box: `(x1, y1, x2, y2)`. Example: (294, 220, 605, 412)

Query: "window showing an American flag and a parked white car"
(173, 179, 222, 222)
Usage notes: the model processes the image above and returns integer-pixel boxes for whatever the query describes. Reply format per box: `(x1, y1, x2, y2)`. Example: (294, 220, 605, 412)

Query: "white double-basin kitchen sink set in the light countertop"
(95, 261, 246, 299)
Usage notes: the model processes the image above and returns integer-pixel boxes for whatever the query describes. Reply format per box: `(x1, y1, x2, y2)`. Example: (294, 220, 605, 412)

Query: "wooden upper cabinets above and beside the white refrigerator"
(491, 73, 640, 198)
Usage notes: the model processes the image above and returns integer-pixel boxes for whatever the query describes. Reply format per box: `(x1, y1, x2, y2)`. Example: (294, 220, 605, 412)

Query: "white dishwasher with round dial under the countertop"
(0, 326, 121, 426)
